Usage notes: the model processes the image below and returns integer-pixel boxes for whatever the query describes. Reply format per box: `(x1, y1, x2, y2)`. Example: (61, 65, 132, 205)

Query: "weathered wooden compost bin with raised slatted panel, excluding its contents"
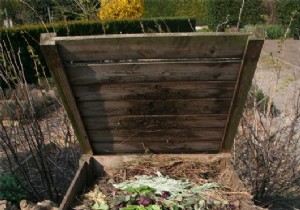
(41, 33, 263, 209)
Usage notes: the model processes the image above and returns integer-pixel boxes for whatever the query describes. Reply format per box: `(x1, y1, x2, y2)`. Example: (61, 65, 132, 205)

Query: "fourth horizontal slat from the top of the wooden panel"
(78, 99, 231, 117)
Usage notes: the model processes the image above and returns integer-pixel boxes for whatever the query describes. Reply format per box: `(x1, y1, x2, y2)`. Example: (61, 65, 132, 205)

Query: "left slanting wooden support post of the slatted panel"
(40, 33, 93, 154)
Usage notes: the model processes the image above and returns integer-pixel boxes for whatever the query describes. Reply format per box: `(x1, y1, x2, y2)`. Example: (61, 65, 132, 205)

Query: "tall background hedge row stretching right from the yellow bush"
(144, 0, 300, 39)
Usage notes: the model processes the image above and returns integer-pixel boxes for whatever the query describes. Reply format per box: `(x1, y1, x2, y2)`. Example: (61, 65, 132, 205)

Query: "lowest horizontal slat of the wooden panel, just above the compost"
(92, 141, 220, 154)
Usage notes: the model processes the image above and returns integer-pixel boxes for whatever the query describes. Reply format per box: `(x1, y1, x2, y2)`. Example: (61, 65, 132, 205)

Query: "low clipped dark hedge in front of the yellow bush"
(0, 17, 196, 83)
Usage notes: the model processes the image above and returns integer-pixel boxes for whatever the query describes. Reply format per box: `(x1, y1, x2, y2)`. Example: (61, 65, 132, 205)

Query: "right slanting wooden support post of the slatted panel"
(220, 39, 264, 152)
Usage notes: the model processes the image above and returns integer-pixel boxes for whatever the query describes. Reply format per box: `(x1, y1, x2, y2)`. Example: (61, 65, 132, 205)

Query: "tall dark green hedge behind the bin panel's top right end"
(206, 0, 263, 31)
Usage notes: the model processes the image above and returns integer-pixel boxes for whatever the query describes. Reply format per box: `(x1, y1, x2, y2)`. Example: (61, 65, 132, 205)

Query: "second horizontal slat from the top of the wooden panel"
(65, 62, 241, 85)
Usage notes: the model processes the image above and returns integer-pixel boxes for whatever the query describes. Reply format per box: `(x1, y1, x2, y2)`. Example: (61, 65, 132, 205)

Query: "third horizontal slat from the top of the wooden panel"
(73, 81, 235, 101)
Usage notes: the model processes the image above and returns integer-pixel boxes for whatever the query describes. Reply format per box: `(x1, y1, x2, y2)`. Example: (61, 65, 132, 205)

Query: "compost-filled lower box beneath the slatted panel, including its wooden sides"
(60, 154, 258, 210)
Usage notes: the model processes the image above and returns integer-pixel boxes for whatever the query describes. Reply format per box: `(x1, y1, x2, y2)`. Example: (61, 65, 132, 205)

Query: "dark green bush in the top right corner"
(276, 0, 300, 39)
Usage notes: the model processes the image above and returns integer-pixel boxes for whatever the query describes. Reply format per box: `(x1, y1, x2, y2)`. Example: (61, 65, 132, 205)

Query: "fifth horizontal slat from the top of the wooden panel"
(83, 114, 227, 130)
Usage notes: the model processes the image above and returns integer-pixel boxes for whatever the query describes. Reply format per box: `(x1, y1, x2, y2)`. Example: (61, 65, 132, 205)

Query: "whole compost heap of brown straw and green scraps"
(73, 156, 255, 210)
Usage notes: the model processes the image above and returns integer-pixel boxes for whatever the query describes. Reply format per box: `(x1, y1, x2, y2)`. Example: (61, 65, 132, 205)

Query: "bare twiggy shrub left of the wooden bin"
(0, 38, 79, 202)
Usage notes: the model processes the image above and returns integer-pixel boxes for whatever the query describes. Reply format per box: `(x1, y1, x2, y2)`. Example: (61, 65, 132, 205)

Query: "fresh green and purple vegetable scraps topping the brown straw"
(74, 172, 229, 210)
